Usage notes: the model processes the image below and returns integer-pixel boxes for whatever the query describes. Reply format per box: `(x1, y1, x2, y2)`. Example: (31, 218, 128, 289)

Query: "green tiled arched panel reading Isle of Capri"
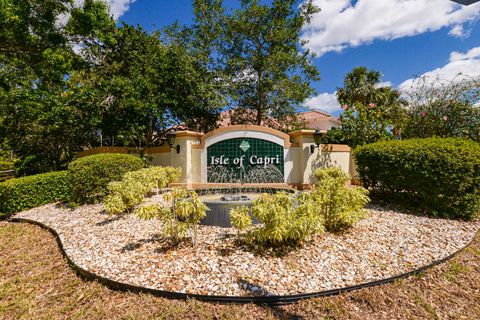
(207, 138, 284, 183)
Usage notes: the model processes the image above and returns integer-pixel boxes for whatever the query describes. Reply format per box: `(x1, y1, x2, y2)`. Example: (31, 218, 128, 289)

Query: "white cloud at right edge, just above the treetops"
(399, 47, 480, 92)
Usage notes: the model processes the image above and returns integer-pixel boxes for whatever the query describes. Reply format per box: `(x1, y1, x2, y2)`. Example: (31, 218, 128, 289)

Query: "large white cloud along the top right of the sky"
(303, 0, 480, 55)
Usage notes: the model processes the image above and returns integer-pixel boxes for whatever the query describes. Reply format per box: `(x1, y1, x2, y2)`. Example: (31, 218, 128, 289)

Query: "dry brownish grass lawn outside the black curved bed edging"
(0, 222, 480, 320)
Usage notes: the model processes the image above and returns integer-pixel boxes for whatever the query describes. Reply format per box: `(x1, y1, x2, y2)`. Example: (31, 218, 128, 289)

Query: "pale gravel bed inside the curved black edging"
(15, 204, 480, 296)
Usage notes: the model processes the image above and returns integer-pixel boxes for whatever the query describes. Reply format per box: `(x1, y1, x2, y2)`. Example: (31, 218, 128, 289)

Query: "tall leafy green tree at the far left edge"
(0, 0, 114, 172)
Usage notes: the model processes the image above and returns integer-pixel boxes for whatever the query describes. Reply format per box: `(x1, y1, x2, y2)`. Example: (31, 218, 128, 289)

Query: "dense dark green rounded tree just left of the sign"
(75, 25, 225, 148)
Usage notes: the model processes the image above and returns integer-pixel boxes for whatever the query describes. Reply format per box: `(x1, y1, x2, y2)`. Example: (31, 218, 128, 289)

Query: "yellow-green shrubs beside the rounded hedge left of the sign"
(104, 167, 180, 214)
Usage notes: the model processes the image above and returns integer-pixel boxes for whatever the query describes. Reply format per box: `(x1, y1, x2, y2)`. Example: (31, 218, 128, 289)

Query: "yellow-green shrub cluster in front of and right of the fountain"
(230, 168, 369, 247)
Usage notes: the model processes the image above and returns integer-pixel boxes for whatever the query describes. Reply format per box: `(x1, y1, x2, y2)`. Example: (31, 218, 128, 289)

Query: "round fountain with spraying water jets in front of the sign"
(197, 165, 293, 227)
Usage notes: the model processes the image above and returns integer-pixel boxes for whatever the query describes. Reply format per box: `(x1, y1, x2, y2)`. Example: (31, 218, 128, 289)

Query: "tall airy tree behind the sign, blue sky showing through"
(168, 0, 319, 129)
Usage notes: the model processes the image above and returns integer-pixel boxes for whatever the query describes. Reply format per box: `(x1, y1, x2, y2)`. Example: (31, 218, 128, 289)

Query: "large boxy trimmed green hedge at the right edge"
(354, 138, 480, 220)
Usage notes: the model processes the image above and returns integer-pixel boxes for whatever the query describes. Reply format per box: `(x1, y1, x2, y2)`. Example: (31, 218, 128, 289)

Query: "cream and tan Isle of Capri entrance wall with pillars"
(78, 125, 355, 189)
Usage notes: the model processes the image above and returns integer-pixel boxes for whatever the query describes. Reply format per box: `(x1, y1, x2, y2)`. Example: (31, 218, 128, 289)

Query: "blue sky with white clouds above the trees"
(103, 0, 480, 115)
